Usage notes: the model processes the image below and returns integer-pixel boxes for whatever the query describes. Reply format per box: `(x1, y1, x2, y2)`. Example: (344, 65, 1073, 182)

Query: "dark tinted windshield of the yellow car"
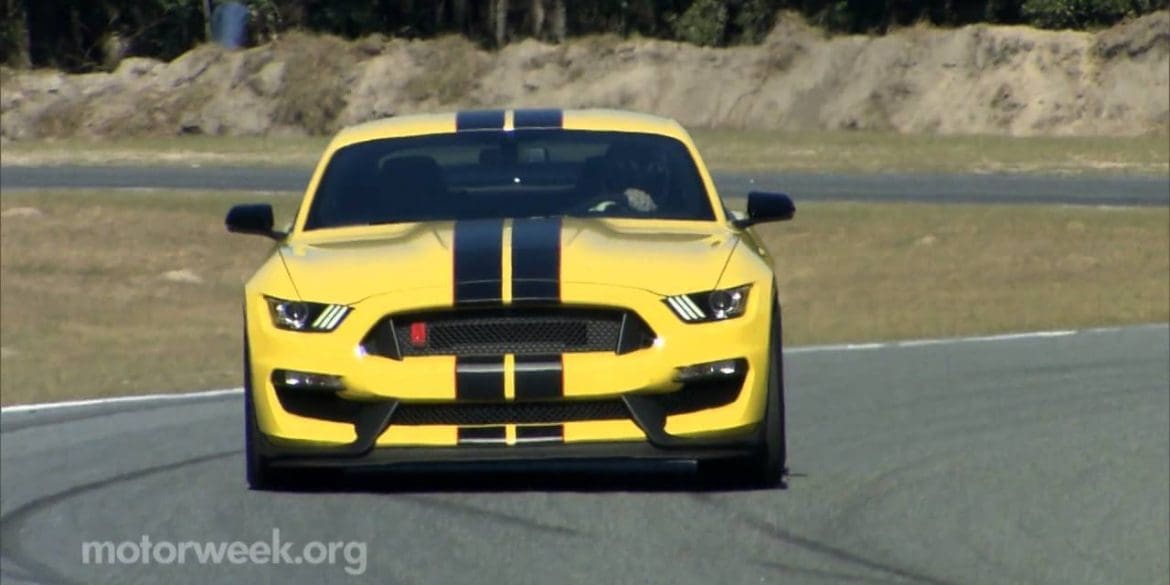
(304, 130, 715, 229)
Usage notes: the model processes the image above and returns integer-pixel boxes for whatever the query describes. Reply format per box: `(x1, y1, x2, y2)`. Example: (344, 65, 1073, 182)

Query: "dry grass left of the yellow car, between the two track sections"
(0, 193, 294, 404)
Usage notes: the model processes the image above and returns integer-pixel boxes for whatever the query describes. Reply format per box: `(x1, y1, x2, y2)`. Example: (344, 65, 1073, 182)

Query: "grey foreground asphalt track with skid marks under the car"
(0, 324, 1170, 585)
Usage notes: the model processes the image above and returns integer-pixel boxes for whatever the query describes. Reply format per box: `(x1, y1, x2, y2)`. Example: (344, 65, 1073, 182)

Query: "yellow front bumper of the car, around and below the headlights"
(247, 284, 771, 449)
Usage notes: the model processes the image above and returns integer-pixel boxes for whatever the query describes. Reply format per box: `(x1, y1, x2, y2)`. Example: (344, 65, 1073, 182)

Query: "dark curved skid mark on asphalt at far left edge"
(0, 449, 241, 585)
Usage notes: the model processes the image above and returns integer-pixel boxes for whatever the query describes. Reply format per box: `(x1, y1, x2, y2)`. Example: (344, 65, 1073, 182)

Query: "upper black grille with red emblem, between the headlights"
(365, 307, 654, 358)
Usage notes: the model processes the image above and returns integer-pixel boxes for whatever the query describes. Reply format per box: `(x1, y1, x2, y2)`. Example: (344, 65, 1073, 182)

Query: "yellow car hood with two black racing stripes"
(278, 218, 738, 303)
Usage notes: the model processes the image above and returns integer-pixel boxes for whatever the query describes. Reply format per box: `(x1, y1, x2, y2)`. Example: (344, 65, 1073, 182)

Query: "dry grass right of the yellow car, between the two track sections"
(761, 204, 1170, 344)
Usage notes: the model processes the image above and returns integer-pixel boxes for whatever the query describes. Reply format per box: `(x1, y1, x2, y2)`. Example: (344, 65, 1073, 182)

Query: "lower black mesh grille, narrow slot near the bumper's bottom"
(391, 400, 629, 425)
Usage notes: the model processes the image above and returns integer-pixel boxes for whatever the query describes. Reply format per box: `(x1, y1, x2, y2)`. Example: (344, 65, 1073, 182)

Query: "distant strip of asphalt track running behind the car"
(0, 166, 1170, 206)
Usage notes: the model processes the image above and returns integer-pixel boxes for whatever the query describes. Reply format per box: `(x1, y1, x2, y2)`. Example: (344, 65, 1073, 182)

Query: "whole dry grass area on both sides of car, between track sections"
(0, 192, 1170, 405)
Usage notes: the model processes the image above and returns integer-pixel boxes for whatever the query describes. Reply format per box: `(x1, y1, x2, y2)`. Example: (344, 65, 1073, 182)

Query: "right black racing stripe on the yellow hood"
(512, 218, 560, 302)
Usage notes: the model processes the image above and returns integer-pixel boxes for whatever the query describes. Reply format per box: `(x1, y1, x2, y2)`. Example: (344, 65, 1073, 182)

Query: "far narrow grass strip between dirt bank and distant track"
(0, 129, 1170, 177)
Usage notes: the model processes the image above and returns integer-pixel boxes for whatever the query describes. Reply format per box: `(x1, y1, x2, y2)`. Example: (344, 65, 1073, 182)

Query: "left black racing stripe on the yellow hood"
(454, 219, 504, 304)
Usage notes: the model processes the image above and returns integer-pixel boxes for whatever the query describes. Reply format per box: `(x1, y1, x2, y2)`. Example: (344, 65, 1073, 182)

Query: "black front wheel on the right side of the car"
(713, 304, 787, 488)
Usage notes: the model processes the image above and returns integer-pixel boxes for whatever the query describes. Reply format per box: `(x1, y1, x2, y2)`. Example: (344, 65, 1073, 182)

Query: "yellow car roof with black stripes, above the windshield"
(332, 109, 690, 149)
